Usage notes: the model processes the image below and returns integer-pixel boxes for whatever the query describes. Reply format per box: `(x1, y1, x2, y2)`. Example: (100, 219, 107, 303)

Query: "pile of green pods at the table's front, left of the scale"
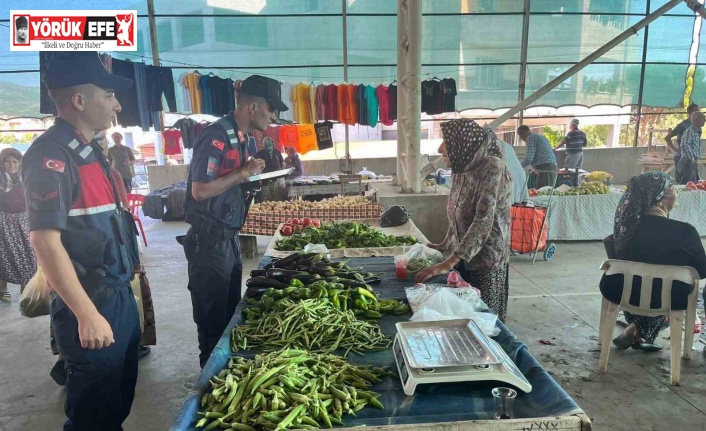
(196, 349, 389, 431)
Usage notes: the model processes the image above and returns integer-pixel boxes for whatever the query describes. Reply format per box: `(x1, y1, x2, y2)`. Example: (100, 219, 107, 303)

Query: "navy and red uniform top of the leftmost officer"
(22, 118, 139, 285)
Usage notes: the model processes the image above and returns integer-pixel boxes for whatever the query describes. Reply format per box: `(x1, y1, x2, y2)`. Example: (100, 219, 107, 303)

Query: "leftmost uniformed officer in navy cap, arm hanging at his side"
(22, 52, 140, 431)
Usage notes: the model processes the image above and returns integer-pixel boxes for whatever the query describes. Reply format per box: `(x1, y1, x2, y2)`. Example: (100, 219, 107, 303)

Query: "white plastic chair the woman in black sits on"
(598, 259, 699, 385)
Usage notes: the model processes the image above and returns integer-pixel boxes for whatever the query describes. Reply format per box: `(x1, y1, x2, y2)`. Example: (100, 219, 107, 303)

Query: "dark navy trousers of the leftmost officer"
(51, 284, 140, 431)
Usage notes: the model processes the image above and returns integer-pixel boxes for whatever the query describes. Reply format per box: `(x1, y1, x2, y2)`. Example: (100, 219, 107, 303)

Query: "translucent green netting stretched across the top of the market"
(0, 0, 706, 115)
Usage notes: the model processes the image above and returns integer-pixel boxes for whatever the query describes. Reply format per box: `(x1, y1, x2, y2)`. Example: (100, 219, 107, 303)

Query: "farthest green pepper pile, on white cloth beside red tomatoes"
(275, 221, 417, 251)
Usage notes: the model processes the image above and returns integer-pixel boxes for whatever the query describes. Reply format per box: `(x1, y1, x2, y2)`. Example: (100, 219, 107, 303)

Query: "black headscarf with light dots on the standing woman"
(441, 118, 502, 174)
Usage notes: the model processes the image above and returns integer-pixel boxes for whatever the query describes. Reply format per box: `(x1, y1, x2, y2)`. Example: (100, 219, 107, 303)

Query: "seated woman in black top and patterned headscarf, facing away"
(600, 172, 706, 352)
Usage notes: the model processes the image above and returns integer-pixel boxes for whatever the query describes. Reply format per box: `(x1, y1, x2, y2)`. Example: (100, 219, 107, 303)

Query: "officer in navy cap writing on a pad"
(179, 75, 288, 368)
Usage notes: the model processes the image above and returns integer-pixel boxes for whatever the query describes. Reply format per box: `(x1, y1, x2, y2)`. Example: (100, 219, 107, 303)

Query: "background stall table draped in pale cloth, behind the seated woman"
(530, 190, 706, 241)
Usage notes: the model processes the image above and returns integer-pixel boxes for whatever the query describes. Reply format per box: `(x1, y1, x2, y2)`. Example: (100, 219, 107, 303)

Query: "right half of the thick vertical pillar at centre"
(403, 0, 422, 193)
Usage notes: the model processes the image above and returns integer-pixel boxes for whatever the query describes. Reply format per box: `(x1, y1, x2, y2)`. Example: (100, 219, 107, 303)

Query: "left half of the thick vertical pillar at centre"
(397, 0, 408, 188)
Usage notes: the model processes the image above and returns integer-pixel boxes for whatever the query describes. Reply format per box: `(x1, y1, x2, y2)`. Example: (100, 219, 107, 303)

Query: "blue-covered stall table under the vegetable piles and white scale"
(170, 257, 590, 431)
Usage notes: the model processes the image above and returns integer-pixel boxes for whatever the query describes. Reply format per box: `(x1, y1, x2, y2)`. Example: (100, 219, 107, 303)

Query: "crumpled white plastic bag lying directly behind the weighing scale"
(410, 288, 500, 336)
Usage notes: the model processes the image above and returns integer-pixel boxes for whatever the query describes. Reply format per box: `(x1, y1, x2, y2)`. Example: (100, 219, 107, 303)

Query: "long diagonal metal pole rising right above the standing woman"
(489, 0, 683, 129)
